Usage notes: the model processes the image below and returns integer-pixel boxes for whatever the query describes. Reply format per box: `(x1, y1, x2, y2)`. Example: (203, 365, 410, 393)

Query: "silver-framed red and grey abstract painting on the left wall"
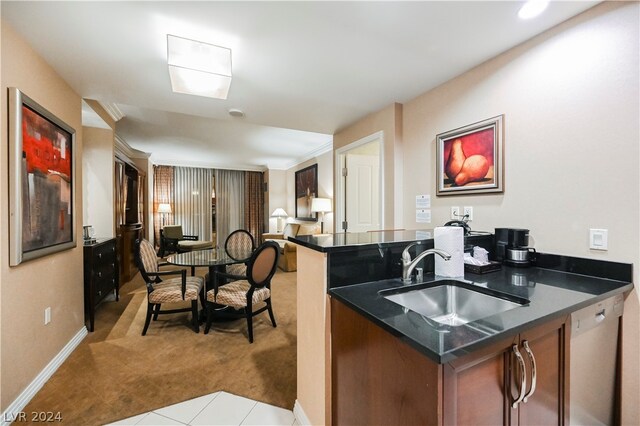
(9, 87, 76, 266)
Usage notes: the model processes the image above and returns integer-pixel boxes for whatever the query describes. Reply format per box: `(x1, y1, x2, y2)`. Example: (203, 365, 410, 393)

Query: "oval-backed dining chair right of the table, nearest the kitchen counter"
(204, 241, 280, 343)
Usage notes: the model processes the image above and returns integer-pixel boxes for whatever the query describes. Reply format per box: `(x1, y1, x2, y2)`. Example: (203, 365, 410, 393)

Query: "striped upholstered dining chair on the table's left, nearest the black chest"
(136, 239, 204, 336)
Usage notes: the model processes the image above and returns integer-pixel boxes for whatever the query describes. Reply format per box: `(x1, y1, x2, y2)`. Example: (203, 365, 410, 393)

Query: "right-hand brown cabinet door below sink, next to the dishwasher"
(514, 318, 569, 425)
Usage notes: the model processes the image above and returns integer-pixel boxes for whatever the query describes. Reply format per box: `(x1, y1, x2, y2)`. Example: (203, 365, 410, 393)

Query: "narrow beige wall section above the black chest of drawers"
(82, 127, 116, 237)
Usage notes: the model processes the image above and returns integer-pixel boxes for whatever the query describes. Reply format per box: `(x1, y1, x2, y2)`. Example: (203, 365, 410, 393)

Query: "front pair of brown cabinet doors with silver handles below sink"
(443, 319, 569, 425)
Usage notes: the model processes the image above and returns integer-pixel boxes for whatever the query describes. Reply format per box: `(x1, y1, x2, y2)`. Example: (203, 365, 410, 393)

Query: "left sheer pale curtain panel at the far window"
(173, 167, 213, 241)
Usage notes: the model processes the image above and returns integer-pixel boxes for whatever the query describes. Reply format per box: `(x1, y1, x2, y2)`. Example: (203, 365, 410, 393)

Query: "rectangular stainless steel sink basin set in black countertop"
(379, 280, 529, 326)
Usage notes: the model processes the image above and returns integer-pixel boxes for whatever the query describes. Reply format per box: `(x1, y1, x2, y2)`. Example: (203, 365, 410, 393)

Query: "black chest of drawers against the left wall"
(84, 238, 120, 331)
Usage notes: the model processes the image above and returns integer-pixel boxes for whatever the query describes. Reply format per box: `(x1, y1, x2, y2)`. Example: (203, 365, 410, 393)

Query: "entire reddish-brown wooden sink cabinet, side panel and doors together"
(331, 299, 569, 425)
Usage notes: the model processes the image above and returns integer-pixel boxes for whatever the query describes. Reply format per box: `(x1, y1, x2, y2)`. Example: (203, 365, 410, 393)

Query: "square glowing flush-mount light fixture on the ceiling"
(167, 34, 231, 99)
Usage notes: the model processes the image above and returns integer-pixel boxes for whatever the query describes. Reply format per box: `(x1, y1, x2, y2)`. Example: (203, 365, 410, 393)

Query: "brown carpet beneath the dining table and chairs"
(24, 269, 296, 425)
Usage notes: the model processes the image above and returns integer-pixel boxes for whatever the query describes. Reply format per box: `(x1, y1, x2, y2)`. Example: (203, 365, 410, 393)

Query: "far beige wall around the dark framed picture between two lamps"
(285, 151, 334, 233)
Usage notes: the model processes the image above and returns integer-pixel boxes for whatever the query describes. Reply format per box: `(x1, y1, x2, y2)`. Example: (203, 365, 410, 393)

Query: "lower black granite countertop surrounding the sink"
(329, 266, 633, 364)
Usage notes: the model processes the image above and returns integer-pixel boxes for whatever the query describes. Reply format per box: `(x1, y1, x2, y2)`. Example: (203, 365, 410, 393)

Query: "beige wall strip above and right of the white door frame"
(332, 104, 402, 229)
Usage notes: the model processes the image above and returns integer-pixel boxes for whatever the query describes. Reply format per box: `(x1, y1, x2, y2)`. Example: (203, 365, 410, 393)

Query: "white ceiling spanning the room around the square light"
(0, 1, 597, 169)
